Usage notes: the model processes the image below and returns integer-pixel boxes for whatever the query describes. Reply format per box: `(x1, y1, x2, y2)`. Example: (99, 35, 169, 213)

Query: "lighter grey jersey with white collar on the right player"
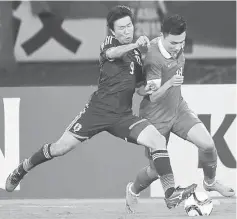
(140, 38, 185, 122)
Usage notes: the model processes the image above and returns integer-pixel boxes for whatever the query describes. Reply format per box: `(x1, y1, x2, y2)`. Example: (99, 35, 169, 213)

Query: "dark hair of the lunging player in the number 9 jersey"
(107, 5, 134, 30)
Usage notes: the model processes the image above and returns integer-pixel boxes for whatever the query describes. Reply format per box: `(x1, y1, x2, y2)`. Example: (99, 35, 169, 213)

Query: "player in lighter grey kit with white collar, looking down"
(127, 15, 235, 212)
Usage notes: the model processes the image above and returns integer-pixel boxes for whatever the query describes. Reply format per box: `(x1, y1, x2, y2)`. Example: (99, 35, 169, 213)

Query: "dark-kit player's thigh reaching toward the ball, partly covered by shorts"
(110, 115, 165, 150)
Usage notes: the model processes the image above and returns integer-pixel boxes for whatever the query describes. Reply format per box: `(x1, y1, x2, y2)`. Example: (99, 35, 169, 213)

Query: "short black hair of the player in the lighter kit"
(161, 14, 187, 35)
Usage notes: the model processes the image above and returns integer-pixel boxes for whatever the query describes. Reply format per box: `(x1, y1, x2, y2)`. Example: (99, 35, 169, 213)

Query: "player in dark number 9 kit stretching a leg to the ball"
(6, 6, 197, 208)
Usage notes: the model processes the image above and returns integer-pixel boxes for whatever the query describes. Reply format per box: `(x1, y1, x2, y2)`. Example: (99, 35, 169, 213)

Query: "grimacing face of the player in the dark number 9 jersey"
(111, 16, 134, 44)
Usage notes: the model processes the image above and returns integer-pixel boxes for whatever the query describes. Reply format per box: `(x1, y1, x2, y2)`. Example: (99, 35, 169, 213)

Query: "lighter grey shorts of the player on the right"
(145, 102, 202, 158)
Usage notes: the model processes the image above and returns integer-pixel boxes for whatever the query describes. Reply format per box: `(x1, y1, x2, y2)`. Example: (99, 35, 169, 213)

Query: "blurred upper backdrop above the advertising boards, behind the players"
(0, 1, 236, 87)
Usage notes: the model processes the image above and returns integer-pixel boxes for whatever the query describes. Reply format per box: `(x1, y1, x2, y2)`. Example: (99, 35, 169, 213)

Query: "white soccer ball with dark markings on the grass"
(184, 192, 213, 217)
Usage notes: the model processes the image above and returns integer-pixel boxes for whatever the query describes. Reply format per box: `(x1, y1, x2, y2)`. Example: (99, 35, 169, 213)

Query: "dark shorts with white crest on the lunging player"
(67, 104, 151, 143)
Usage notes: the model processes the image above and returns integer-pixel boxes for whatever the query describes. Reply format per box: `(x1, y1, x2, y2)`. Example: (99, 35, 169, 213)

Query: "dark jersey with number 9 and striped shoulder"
(91, 36, 142, 113)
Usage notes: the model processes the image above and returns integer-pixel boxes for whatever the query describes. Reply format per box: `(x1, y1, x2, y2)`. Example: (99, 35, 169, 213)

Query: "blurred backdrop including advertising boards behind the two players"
(0, 1, 236, 199)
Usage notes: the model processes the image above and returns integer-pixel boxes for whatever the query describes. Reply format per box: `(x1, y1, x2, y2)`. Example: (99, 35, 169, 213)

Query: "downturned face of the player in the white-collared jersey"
(162, 32, 186, 58)
